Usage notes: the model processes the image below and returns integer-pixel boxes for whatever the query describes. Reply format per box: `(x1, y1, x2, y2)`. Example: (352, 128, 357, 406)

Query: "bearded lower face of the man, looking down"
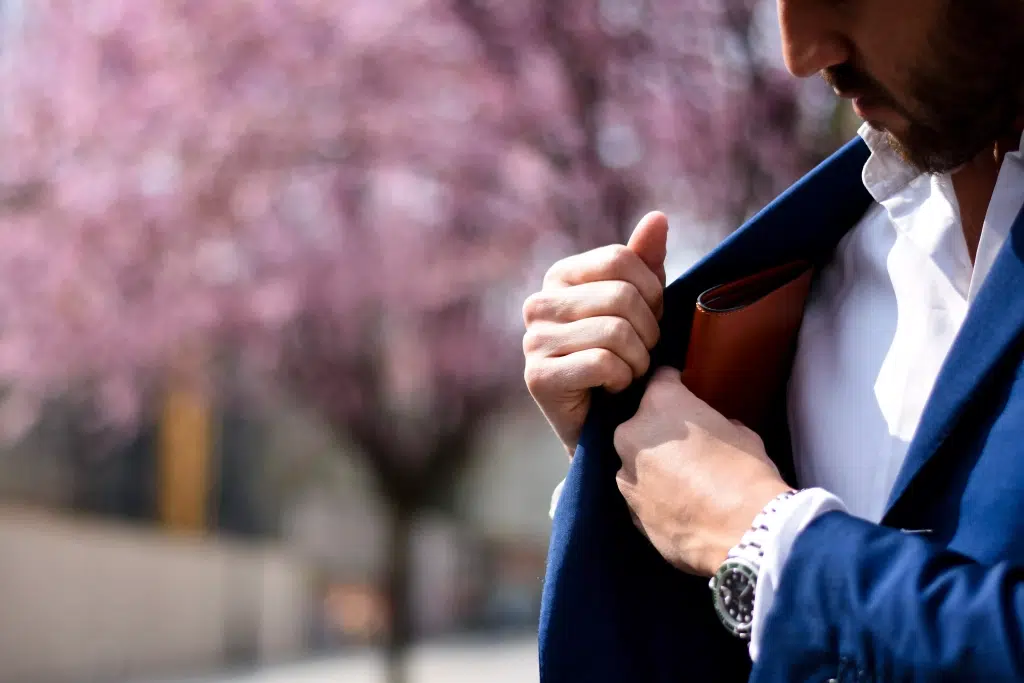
(778, 0, 1024, 173)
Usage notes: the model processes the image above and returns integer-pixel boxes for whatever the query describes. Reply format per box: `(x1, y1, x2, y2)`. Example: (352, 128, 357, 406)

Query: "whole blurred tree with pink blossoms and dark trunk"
(0, 0, 821, 680)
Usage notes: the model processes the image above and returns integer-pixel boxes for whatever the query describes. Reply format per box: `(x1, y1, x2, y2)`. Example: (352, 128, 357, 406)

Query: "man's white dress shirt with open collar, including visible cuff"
(751, 125, 1024, 659)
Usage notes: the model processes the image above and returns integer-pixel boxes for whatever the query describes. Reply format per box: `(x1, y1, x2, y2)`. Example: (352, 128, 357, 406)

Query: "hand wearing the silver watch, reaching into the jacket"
(614, 368, 790, 577)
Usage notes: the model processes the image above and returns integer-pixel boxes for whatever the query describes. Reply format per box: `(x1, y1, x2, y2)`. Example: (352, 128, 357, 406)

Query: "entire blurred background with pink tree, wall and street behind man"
(0, 0, 854, 683)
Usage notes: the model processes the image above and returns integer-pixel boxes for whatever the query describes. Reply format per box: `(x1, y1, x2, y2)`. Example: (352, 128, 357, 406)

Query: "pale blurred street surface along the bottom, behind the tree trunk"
(141, 638, 539, 683)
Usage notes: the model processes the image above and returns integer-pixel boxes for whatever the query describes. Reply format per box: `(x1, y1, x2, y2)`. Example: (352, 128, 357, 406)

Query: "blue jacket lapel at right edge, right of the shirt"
(883, 200, 1024, 523)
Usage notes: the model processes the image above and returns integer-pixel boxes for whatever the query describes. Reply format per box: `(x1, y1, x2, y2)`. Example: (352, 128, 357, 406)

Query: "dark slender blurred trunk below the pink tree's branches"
(385, 503, 415, 683)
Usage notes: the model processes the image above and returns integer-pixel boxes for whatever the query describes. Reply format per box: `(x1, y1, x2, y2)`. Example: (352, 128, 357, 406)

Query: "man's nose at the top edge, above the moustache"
(778, 0, 851, 78)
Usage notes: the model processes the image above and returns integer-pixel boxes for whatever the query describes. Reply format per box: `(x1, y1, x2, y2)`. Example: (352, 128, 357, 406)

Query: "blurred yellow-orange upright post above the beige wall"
(157, 356, 213, 533)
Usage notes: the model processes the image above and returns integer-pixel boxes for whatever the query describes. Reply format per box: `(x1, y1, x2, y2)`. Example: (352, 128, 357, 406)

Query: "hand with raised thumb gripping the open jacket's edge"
(522, 212, 669, 455)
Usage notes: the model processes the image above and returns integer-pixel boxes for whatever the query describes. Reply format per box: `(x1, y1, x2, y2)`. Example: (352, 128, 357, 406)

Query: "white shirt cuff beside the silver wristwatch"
(750, 488, 846, 661)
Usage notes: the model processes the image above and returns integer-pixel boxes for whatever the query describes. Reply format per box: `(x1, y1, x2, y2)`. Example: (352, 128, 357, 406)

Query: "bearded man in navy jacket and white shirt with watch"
(524, 0, 1024, 683)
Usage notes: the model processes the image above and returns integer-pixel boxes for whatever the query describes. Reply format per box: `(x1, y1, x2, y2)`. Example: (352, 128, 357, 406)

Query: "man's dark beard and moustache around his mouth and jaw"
(821, 0, 1024, 173)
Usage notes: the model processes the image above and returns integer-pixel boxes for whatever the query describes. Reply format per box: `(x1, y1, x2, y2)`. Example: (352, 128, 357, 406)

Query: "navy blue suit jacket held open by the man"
(540, 139, 1024, 683)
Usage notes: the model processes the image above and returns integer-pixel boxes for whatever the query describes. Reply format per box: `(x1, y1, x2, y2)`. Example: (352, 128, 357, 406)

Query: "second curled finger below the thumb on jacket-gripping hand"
(523, 281, 660, 349)
